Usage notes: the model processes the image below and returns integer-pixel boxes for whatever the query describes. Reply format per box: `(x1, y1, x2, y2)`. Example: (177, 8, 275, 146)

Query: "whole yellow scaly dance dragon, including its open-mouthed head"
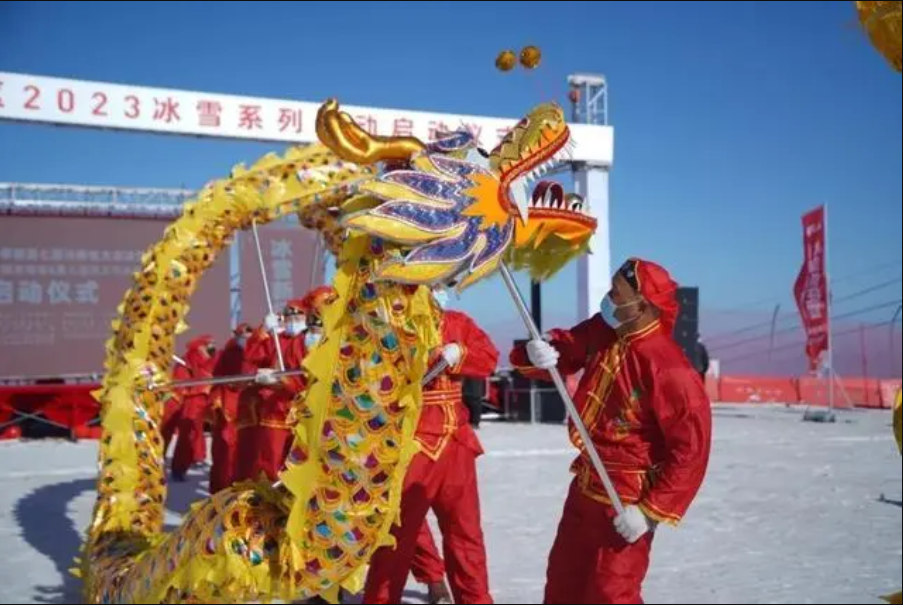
(77, 101, 595, 603)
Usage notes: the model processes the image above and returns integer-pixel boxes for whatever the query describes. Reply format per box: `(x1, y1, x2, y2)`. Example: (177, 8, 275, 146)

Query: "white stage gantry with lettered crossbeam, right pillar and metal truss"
(0, 72, 614, 330)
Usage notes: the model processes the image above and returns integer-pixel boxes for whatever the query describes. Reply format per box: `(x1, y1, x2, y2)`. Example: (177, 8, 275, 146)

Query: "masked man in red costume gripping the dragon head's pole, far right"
(511, 258, 712, 603)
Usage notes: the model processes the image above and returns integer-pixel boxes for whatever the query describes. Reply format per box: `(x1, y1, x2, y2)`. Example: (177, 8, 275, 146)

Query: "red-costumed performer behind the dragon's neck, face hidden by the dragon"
(364, 290, 498, 603)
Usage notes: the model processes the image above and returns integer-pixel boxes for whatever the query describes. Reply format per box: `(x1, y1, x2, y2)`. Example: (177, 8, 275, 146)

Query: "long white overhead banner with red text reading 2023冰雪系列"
(0, 71, 614, 166)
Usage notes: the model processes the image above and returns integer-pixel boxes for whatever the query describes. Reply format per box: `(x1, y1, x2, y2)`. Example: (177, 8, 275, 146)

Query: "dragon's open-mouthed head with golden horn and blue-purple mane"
(317, 101, 596, 290)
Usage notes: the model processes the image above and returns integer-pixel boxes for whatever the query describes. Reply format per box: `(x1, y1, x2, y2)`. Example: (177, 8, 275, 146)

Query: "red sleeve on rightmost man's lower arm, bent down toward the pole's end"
(640, 366, 712, 525)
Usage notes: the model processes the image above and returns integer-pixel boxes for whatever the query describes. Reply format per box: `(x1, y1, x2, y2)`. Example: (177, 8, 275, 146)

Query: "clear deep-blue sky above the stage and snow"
(0, 2, 903, 332)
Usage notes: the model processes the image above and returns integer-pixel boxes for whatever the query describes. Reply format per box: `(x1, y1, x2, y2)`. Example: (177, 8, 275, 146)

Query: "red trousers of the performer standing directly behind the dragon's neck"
(364, 440, 493, 604)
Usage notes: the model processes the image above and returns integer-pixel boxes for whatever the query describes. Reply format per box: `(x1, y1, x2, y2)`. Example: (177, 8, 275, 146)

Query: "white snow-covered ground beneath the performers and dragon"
(0, 406, 903, 603)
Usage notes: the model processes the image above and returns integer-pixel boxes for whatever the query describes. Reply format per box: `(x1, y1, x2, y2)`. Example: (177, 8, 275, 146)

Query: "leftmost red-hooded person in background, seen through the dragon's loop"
(172, 335, 217, 481)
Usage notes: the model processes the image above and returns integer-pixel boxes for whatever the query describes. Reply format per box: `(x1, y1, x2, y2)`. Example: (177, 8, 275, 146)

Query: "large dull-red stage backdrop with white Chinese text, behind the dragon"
(0, 216, 229, 376)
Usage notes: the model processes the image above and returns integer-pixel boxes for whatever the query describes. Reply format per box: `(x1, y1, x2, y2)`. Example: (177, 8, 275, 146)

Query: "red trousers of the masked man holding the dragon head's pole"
(543, 480, 653, 604)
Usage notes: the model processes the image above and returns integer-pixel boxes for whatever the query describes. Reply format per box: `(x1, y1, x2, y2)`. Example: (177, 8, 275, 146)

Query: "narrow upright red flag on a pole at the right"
(793, 206, 830, 371)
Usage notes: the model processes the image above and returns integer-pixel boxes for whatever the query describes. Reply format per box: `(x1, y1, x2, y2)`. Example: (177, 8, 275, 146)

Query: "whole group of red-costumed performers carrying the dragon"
(163, 259, 711, 603)
